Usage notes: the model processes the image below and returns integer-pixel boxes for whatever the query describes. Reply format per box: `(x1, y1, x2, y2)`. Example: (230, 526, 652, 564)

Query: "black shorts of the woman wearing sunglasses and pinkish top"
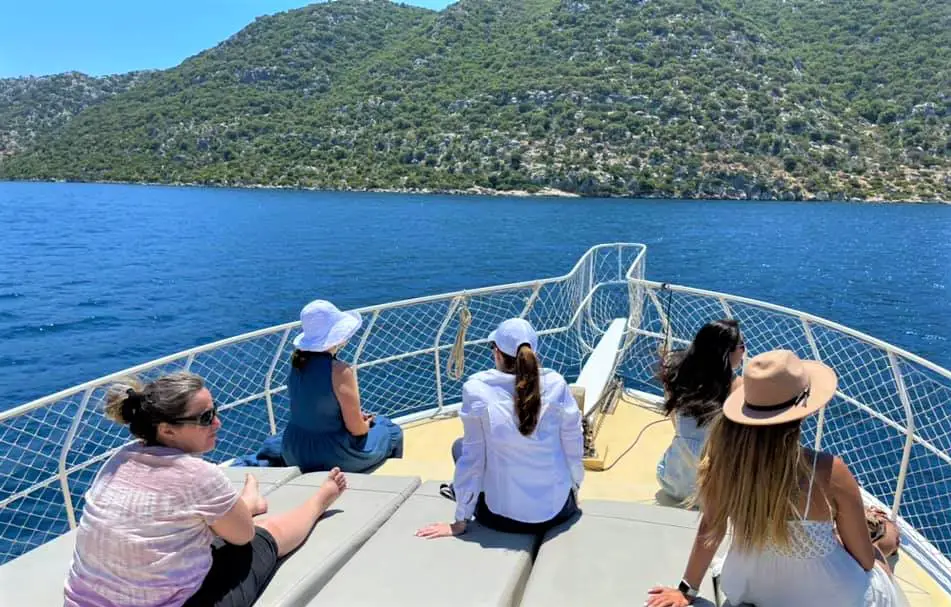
(183, 527, 277, 607)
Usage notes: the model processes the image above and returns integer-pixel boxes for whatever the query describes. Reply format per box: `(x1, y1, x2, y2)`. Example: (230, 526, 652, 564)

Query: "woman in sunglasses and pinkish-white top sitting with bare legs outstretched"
(65, 372, 347, 607)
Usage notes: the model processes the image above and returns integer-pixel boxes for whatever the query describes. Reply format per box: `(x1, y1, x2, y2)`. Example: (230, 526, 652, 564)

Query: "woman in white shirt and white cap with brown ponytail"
(416, 318, 584, 538)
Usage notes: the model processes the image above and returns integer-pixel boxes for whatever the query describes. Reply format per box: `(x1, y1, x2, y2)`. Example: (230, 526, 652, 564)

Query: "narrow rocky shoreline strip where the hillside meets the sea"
(0, 179, 951, 205)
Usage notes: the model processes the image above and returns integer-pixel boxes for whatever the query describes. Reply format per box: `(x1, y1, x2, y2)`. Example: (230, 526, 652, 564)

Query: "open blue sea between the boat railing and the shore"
(0, 183, 951, 410)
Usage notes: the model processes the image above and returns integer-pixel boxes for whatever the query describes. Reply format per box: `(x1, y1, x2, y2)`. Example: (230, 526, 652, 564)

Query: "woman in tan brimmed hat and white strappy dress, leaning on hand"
(646, 350, 907, 607)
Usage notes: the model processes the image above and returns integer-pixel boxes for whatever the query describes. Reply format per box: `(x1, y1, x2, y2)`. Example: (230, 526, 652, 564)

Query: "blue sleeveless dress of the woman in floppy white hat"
(282, 354, 403, 472)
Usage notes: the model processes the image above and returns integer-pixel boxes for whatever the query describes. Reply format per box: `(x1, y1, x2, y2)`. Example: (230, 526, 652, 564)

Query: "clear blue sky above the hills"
(0, 0, 451, 78)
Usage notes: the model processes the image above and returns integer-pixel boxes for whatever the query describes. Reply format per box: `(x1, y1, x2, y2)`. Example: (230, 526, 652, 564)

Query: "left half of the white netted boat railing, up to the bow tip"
(0, 243, 646, 563)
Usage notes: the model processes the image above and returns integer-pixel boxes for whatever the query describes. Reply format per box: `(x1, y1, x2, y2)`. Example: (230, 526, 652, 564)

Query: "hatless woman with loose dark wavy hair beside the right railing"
(657, 320, 746, 502)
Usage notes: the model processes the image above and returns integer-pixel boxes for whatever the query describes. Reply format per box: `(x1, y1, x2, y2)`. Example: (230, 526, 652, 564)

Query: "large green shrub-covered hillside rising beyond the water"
(0, 0, 951, 200)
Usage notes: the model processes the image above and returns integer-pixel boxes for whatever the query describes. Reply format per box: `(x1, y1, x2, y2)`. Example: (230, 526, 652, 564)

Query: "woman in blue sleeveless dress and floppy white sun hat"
(282, 299, 403, 472)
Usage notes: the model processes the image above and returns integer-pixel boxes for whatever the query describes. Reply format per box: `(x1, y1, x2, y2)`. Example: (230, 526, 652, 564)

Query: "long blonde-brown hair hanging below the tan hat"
(695, 415, 811, 551)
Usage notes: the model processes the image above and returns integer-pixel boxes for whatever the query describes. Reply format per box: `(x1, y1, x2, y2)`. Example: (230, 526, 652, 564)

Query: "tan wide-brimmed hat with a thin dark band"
(723, 350, 837, 426)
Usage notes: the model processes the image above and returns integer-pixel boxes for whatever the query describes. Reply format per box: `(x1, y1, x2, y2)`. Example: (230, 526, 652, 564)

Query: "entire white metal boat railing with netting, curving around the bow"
(0, 243, 951, 588)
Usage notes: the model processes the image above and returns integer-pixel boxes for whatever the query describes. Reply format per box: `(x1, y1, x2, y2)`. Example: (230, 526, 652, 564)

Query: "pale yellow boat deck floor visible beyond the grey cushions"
(374, 397, 951, 607)
